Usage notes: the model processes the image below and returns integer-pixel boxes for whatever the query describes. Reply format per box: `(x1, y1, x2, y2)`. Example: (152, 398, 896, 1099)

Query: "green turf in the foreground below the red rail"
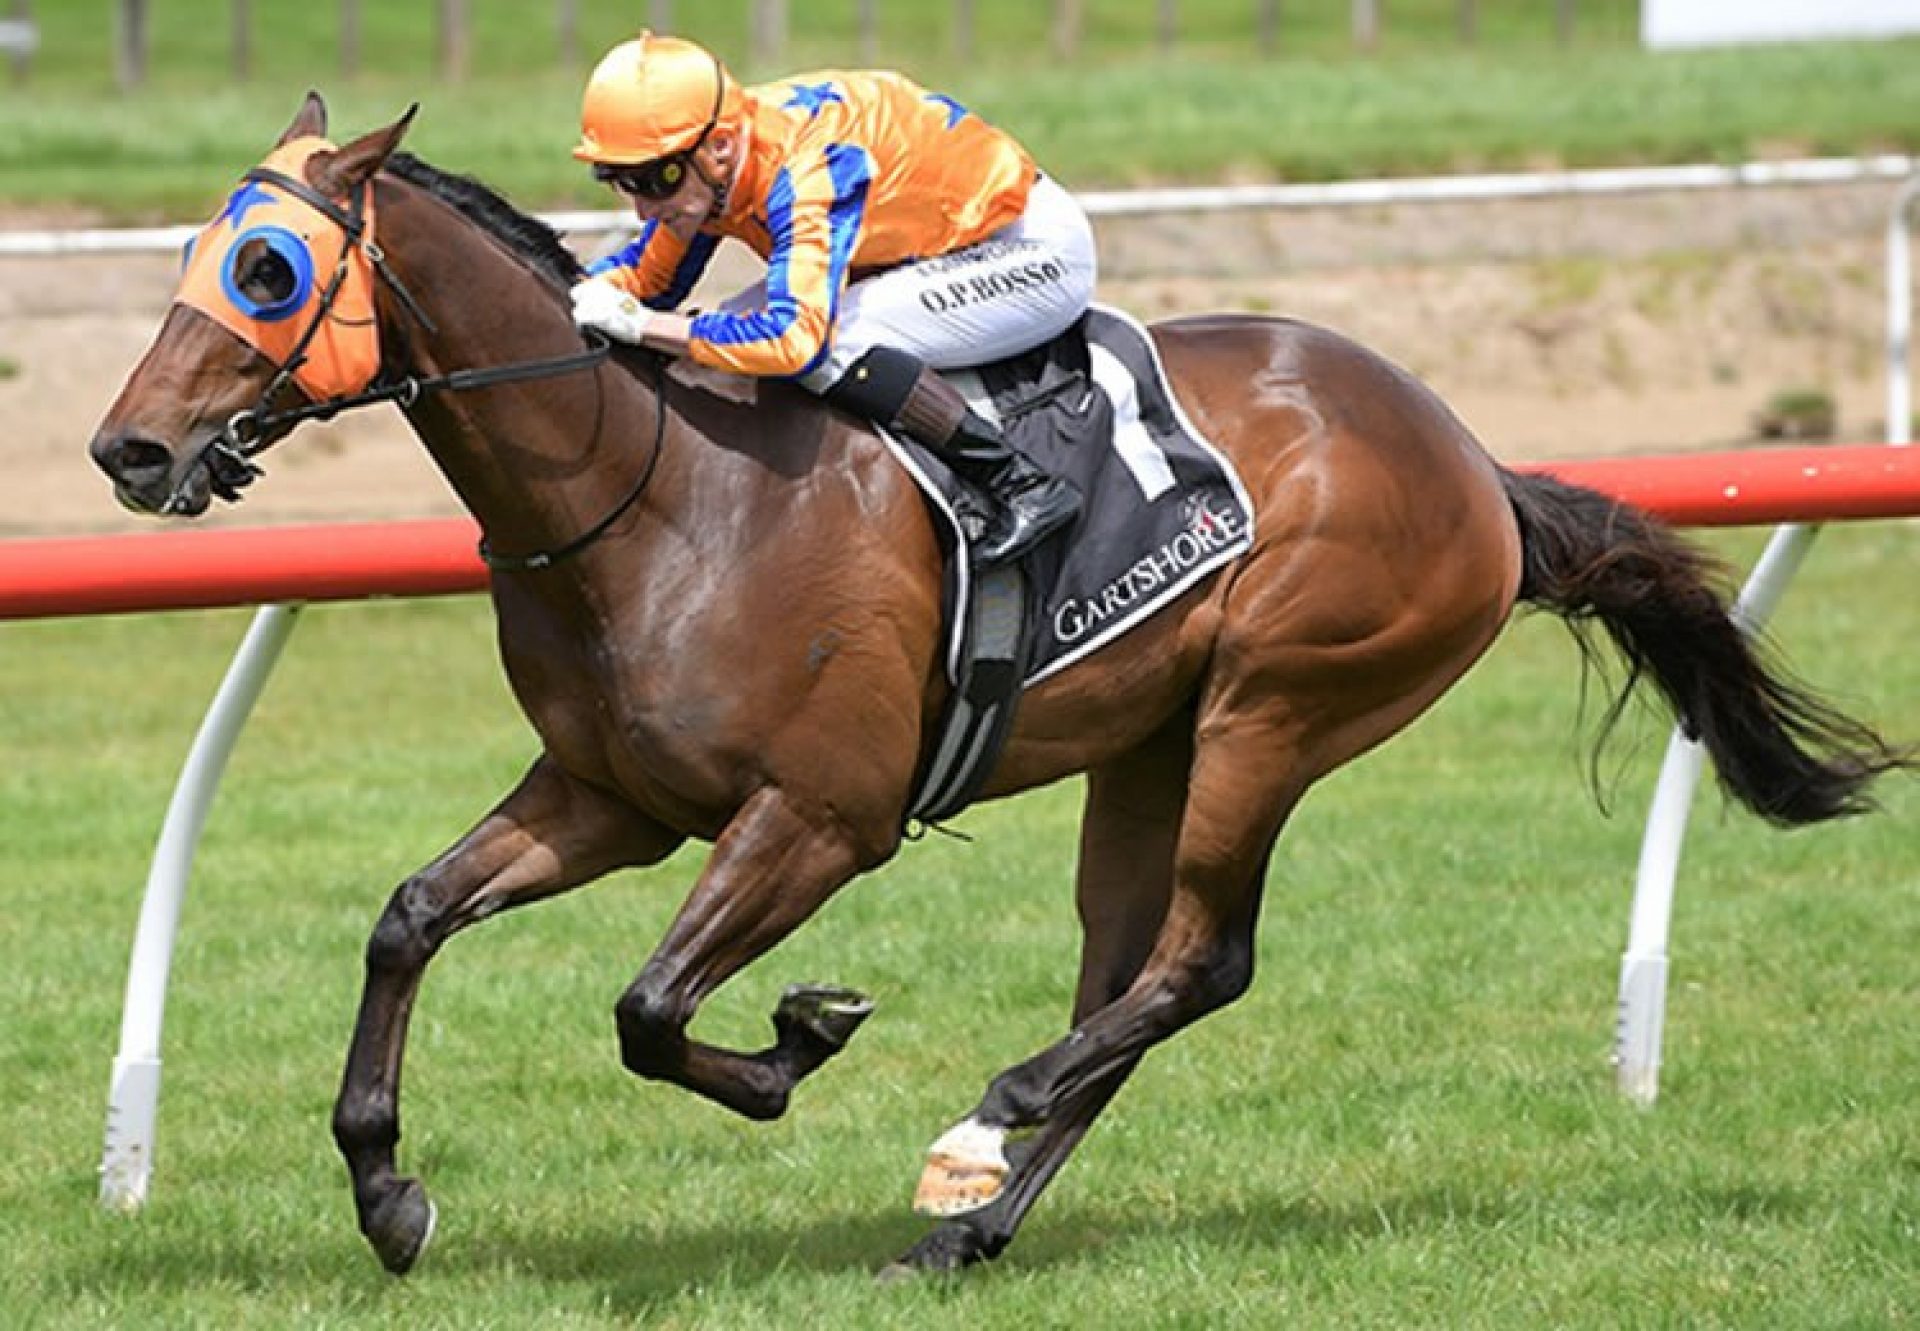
(0, 524, 1920, 1331)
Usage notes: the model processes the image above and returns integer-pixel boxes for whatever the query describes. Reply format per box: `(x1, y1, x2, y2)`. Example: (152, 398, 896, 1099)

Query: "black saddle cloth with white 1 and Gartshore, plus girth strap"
(883, 305, 1254, 686)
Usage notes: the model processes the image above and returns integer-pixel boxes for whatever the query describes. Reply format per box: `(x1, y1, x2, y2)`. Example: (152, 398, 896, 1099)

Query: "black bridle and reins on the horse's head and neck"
(172, 167, 666, 572)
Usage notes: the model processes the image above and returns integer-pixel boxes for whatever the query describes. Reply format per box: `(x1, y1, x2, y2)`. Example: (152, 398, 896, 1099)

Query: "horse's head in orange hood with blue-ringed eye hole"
(88, 92, 413, 517)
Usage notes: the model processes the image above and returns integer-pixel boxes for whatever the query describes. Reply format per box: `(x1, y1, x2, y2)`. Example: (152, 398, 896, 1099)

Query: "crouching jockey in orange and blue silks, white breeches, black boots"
(572, 33, 1094, 565)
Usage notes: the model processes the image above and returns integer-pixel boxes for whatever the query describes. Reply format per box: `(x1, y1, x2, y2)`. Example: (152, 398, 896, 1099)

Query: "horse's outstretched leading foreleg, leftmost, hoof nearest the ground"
(334, 759, 682, 1273)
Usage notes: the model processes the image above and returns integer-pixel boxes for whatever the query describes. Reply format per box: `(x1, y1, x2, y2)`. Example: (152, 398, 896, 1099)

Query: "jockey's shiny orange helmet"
(574, 33, 741, 167)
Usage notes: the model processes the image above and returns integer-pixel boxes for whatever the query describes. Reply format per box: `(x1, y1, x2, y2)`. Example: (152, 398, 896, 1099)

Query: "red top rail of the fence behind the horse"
(0, 444, 1920, 618)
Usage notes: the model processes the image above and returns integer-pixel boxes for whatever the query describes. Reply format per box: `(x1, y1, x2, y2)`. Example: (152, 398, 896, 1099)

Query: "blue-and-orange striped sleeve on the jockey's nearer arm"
(689, 144, 874, 376)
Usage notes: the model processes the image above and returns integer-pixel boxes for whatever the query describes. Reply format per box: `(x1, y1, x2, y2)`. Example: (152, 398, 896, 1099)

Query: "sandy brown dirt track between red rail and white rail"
(0, 184, 1893, 536)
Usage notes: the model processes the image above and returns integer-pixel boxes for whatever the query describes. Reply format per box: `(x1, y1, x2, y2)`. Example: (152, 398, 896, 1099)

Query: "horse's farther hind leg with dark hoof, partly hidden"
(883, 713, 1192, 1277)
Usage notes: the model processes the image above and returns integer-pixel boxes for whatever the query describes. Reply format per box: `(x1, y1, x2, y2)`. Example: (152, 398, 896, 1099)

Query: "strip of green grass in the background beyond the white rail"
(0, 0, 1920, 219)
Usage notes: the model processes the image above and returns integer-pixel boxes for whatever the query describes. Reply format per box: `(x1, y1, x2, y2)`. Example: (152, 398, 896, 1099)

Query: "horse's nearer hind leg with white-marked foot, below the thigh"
(916, 726, 1300, 1236)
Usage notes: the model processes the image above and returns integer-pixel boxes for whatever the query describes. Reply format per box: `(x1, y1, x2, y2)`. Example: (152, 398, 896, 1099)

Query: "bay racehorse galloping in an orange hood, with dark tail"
(90, 94, 1905, 1273)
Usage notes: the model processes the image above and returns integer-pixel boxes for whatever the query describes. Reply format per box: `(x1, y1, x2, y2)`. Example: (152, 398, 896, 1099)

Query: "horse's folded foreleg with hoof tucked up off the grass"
(614, 786, 872, 1120)
